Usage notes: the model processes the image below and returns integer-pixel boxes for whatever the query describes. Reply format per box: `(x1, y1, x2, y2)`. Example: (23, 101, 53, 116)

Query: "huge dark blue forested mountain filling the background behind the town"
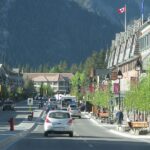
(0, 0, 150, 67)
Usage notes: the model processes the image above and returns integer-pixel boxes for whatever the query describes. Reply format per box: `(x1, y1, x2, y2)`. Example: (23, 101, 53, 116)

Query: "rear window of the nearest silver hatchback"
(49, 112, 70, 119)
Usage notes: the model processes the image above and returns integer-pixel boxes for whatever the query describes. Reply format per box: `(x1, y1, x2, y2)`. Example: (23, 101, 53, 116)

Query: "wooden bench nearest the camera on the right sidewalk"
(129, 121, 149, 134)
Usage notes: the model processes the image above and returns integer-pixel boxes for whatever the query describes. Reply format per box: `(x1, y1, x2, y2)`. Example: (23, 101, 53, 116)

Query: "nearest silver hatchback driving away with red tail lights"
(44, 110, 73, 137)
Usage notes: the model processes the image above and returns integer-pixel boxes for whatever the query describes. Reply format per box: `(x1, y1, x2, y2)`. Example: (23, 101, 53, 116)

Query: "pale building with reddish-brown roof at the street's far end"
(23, 73, 73, 94)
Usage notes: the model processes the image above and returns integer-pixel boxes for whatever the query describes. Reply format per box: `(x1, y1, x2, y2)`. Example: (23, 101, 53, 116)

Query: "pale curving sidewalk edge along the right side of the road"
(83, 112, 150, 143)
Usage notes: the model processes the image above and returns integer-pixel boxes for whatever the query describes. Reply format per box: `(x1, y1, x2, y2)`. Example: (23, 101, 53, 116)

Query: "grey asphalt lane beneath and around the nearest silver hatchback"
(3, 114, 150, 150)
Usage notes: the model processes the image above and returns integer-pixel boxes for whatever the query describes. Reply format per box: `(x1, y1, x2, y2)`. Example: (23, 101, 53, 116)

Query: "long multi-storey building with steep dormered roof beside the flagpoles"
(107, 19, 150, 110)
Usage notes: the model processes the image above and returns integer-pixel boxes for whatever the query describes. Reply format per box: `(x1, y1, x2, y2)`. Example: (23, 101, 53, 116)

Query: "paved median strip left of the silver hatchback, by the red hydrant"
(0, 110, 43, 150)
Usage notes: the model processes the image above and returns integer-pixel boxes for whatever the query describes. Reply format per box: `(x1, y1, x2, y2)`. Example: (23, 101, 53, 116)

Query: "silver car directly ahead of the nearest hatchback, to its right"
(67, 104, 81, 118)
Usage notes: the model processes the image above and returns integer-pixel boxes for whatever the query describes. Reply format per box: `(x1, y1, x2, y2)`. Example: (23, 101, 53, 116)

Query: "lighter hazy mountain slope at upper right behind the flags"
(70, 0, 150, 25)
